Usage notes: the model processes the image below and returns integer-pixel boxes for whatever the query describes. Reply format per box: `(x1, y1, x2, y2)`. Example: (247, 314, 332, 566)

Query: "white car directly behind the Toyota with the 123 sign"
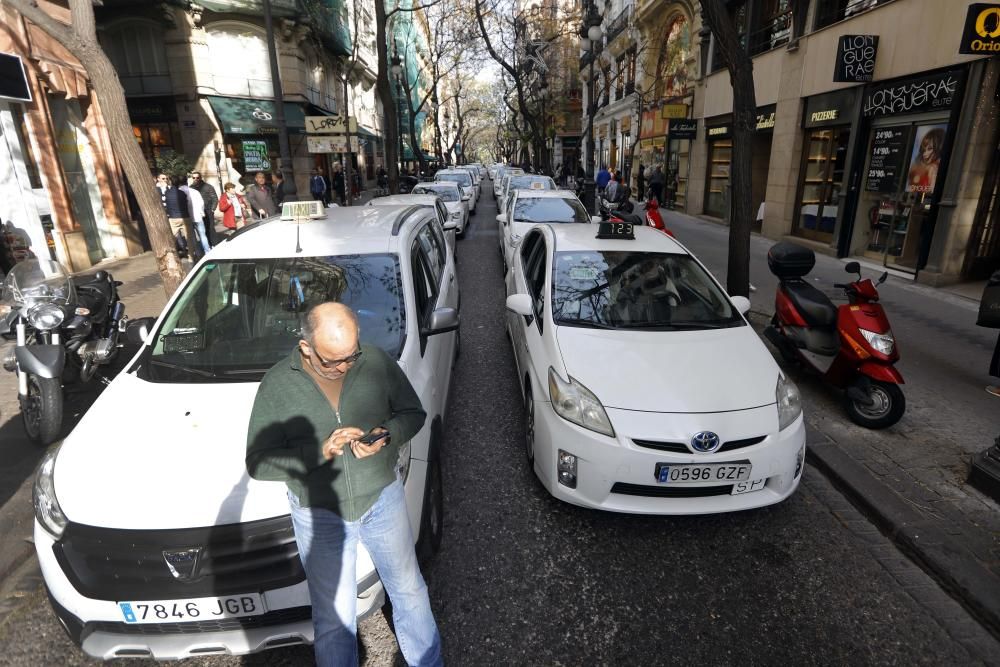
(497, 190, 601, 270)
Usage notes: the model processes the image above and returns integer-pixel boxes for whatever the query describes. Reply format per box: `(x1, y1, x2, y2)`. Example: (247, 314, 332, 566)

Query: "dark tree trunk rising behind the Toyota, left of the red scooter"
(701, 0, 757, 297)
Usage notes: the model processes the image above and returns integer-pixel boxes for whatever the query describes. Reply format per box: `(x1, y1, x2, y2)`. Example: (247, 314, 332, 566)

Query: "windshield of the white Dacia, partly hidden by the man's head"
(140, 254, 406, 383)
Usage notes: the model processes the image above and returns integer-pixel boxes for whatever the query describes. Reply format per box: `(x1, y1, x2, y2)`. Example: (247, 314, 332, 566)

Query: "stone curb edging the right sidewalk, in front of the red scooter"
(806, 442, 1000, 639)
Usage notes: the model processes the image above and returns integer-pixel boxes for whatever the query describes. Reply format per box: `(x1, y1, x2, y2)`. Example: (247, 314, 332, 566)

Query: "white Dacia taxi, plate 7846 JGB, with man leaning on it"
(34, 202, 458, 660)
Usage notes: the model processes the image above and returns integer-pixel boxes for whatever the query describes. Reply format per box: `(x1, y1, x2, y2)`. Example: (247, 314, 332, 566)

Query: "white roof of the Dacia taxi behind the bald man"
(208, 204, 431, 261)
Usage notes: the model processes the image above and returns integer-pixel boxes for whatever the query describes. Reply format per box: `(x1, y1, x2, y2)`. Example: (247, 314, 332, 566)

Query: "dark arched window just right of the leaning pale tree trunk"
(100, 20, 170, 95)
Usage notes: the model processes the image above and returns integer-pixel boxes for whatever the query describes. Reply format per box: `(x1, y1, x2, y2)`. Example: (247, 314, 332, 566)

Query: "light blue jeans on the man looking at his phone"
(288, 479, 443, 667)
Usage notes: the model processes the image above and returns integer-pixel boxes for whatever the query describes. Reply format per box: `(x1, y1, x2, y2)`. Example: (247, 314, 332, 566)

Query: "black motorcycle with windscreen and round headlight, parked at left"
(0, 259, 125, 445)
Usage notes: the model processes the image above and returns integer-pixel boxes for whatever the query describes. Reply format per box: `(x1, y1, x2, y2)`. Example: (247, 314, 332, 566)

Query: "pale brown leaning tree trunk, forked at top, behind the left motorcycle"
(3, 0, 185, 296)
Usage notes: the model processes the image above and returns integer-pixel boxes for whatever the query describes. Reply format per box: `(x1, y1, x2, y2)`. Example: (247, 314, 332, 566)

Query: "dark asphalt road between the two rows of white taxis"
(0, 190, 996, 665)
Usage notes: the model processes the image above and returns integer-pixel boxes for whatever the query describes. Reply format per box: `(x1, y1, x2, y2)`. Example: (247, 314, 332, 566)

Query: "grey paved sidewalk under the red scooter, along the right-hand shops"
(656, 208, 1000, 637)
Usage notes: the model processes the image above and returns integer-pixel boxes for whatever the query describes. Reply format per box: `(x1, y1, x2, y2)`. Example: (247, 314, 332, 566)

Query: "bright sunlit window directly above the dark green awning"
(206, 22, 274, 97)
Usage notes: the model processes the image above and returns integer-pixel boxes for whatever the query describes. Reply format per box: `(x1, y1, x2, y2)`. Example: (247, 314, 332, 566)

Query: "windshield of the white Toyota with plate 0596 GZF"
(552, 251, 744, 331)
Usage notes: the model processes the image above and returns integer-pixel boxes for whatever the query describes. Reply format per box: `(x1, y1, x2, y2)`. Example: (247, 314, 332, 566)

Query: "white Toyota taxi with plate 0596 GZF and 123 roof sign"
(507, 223, 806, 514)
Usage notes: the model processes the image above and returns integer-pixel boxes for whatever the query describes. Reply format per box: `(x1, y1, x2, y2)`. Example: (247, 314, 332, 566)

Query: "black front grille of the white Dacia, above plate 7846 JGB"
(52, 515, 305, 602)
